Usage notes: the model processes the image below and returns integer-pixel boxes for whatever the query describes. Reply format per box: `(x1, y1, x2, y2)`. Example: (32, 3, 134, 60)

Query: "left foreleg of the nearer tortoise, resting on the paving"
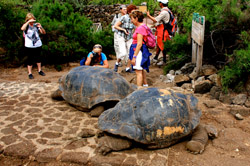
(98, 136, 132, 155)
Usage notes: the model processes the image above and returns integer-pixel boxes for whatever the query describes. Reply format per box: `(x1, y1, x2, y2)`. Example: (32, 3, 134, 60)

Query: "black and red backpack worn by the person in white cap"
(163, 8, 177, 39)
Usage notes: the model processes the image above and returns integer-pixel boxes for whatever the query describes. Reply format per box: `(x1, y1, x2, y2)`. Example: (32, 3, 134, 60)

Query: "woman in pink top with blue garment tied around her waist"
(129, 11, 151, 87)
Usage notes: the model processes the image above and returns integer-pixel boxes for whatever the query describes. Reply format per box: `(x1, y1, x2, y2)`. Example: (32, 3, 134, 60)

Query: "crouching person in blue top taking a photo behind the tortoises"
(85, 44, 109, 68)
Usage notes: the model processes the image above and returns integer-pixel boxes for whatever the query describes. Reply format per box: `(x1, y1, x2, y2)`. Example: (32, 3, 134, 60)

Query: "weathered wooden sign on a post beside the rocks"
(192, 13, 205, 74)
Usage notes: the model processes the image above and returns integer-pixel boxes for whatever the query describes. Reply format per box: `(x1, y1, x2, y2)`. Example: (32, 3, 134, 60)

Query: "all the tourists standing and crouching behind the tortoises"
(21, 0, 170, 87)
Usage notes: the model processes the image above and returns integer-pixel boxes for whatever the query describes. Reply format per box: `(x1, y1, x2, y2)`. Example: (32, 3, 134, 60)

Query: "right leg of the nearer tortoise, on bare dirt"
(186, 125, 208, 154)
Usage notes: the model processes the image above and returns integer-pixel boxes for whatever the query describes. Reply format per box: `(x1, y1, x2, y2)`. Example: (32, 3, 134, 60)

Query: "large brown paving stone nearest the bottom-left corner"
(3, 141, 37, 158)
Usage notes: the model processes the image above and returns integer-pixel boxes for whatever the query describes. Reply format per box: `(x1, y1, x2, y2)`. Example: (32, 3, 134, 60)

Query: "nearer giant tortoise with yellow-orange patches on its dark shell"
(98, 88, 217, 155)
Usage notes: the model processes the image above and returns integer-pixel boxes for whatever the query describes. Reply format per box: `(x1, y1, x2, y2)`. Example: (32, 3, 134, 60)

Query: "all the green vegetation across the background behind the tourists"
(0, 0, 250, 91)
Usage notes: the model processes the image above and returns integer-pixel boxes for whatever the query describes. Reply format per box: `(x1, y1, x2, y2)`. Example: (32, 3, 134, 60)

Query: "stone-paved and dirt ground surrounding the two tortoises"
(0, 60, 250, 166)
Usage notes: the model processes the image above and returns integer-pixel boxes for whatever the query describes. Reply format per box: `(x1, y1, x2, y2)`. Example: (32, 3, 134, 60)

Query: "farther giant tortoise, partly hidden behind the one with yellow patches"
(51, 66, 133, 116)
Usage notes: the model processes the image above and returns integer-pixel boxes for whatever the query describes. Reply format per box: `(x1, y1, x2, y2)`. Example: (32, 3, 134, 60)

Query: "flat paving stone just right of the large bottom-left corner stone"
(36, 148, 63, 162)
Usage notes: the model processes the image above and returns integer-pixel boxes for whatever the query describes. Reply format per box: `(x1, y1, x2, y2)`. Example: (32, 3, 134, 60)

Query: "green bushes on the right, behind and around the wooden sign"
(164, 0, 250, 92)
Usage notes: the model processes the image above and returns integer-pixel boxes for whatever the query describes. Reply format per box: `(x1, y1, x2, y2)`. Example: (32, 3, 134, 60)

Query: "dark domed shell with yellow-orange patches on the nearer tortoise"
(98, 88, 201, 148)
